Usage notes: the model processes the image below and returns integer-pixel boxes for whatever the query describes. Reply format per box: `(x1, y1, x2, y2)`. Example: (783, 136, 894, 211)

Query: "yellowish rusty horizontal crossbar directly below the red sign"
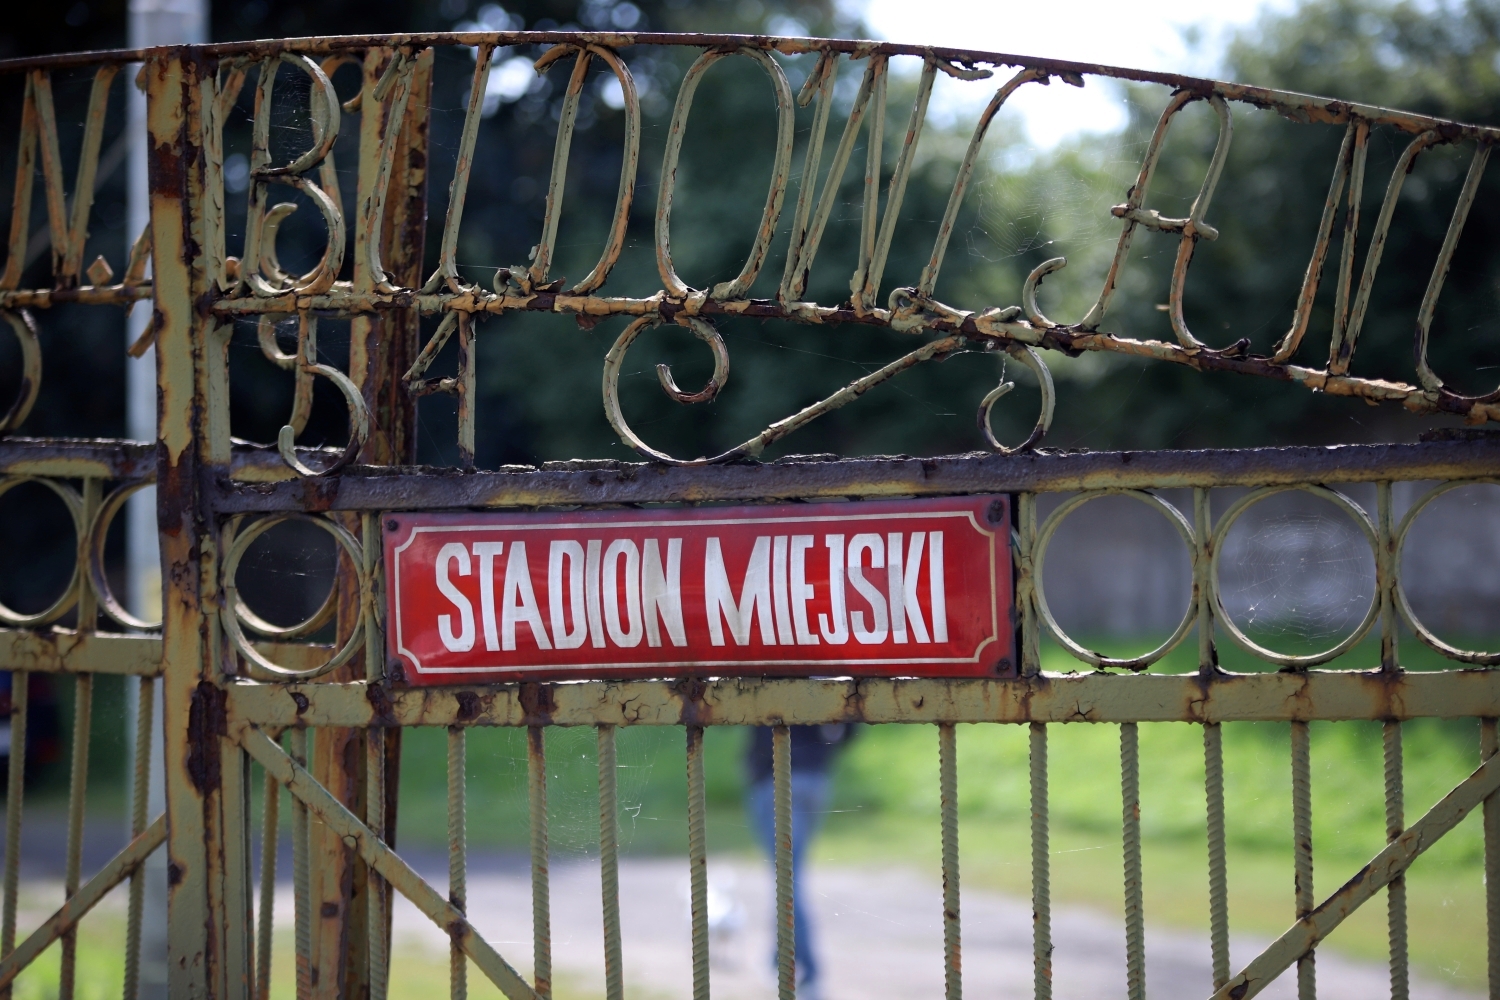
(219, 670, 1500, 727)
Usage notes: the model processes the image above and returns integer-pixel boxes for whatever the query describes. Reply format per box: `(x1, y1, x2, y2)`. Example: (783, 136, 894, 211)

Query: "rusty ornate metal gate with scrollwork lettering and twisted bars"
(0, 33, 1500, 1000)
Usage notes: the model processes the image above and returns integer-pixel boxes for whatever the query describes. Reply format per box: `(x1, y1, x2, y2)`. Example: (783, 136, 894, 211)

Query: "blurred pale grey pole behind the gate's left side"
(125, 0, 209, 1000)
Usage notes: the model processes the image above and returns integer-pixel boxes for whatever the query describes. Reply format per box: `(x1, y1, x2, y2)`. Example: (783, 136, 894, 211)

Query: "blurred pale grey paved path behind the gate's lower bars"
(372, 858, 1478, 1000)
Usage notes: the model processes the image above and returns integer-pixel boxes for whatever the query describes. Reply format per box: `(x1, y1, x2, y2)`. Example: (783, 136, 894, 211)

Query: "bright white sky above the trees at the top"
(852, 0, 1293, 148)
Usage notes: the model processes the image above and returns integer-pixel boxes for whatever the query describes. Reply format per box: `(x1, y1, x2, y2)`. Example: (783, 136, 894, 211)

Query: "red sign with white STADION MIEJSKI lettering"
(386, 496, 1014, 684)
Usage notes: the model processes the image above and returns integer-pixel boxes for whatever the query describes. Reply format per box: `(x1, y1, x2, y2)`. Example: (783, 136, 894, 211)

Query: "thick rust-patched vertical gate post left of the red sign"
(150, 46, 229, 997)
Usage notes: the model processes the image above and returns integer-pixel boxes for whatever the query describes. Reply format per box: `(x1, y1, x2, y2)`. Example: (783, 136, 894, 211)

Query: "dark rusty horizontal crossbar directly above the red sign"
(213, 435, 1500, 514)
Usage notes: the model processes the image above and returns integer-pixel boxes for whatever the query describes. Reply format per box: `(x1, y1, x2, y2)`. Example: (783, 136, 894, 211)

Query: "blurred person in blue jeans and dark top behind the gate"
(746, 723, 854, 1000)
